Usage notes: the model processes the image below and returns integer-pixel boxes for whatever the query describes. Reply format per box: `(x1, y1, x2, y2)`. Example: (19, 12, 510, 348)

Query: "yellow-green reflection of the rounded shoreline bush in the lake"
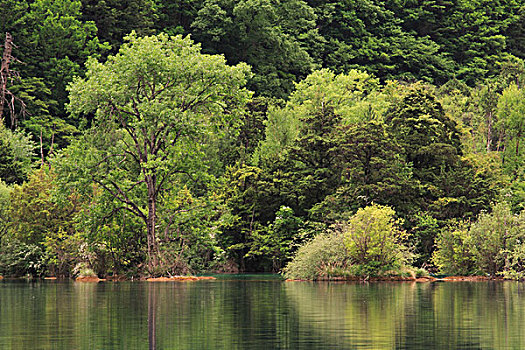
(286, 283, 416, 349)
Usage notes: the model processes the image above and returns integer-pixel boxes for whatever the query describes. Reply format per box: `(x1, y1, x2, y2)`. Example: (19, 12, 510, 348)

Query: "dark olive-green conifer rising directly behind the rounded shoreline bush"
(312, 121, 418, 220)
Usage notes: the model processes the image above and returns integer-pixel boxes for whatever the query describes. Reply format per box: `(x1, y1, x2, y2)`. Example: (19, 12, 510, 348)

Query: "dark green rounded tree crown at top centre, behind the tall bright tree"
(192, 0, 316, 98)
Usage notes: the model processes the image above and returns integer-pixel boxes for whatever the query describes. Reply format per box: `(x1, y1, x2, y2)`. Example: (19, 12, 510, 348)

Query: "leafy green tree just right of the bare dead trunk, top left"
(13, 0, 106, 117)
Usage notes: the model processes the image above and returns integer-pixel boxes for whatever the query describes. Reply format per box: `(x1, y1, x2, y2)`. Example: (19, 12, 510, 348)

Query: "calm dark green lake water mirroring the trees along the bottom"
(0, 279, 525, 350)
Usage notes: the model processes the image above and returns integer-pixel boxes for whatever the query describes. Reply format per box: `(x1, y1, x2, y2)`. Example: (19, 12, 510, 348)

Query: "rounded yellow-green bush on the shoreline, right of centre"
(284, 204, 421, 280)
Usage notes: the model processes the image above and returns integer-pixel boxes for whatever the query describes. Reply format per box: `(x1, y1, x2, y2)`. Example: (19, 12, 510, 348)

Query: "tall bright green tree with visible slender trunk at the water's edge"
(65, 35, 249, 273)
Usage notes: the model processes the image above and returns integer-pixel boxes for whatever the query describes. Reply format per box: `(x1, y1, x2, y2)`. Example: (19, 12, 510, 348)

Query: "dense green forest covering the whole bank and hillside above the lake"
(0, 0, 525, 279)
